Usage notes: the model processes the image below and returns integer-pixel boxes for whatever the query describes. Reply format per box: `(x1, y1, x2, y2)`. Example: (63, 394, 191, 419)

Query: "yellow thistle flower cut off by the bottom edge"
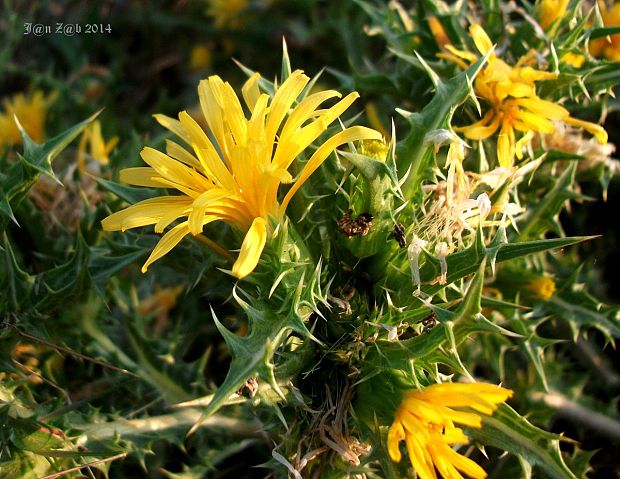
(387, 383, 513, 479)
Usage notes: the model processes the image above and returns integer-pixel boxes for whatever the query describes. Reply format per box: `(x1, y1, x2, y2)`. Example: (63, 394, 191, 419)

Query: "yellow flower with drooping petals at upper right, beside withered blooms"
(452, 24, 607, 168)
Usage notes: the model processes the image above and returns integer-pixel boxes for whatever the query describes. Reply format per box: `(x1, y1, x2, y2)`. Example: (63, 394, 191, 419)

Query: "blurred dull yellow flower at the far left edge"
(0, 90, 55, 148)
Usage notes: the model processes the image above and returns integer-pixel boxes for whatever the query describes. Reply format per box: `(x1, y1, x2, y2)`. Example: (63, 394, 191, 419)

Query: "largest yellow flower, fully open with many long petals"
(102, 70, 381, 278)
